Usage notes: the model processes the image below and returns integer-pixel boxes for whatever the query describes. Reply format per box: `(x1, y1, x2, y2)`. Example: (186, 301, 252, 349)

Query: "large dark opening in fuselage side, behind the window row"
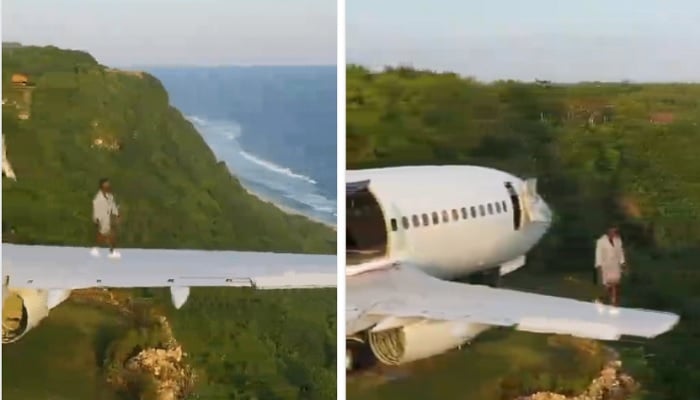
(345, 180, 387, 265)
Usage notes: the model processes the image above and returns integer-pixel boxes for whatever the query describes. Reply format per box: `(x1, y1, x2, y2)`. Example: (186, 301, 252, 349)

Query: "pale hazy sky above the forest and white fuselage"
(346, 0, 700, 81)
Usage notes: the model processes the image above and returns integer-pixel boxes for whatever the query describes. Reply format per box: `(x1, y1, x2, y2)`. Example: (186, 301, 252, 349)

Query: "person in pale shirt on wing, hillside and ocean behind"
(91, 178, 121, 258)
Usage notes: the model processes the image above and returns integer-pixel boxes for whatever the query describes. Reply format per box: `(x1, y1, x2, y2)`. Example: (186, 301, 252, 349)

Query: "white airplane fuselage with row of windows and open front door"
(347, 166, 551, 279)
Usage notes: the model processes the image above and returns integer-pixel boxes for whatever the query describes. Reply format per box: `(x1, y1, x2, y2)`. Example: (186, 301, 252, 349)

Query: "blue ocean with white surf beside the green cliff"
(143, 66, 337, 226)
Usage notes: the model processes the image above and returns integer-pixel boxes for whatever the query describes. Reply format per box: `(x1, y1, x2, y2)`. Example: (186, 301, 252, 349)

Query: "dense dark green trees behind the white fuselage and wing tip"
(347, 66, 700, 399)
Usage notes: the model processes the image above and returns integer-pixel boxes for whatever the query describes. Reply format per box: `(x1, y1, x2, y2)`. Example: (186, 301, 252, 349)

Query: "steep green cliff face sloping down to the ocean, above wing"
(3, 47, 335, 253)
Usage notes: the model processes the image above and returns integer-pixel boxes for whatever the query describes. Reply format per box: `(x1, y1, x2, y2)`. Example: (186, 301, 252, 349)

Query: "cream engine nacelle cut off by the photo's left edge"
(2, 286, 71, 343)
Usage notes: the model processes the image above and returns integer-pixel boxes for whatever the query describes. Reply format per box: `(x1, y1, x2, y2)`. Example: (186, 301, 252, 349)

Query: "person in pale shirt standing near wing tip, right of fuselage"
(595, 227, 625, 306)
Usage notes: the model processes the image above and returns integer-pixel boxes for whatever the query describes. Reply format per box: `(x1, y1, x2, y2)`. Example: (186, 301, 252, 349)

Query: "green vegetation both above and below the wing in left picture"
(2, 46, 336, 399)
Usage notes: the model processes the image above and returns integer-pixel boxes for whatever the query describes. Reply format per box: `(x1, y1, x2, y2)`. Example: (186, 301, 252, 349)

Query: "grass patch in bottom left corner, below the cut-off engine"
(2, 299, 127, 400)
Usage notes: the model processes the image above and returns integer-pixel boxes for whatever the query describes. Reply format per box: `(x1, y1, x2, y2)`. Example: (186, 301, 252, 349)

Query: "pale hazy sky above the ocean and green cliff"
(2, 0, 337, 66)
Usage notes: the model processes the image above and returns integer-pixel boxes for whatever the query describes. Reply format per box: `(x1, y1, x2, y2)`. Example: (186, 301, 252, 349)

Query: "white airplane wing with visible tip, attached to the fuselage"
(346, 264, 678, 340)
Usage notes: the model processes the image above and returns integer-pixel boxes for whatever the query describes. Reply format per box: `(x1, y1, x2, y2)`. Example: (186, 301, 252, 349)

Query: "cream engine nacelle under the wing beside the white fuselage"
(368, 320, 489, 365)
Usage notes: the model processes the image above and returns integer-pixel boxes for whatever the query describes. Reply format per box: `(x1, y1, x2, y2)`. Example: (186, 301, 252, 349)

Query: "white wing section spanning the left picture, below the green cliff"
(2, 244, 336, 290)
